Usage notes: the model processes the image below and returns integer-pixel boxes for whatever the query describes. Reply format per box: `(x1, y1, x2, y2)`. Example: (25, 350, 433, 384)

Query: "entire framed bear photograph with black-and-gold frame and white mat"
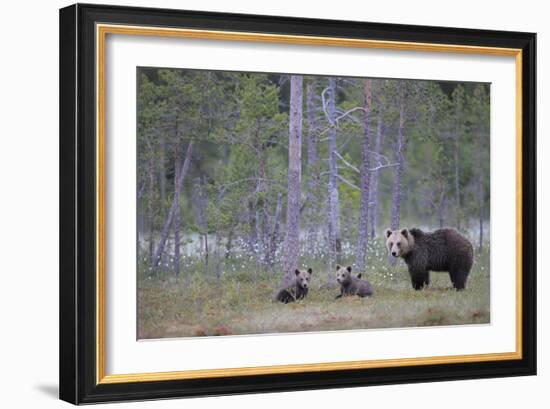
(60, 5, 536, 404)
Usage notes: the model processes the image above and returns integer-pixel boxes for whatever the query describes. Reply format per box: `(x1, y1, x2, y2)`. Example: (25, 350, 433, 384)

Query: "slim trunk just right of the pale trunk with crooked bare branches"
(355, 80, 372, 271)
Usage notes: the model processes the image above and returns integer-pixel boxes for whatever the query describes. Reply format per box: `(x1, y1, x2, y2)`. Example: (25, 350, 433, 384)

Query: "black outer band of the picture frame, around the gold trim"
(59, 4, 536, 404)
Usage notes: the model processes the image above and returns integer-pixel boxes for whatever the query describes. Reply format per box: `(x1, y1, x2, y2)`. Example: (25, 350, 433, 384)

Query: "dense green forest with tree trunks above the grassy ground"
(137, 68, 490, 281)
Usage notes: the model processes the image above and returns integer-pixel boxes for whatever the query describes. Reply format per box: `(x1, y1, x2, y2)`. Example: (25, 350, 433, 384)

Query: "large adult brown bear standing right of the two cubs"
(386, 229, 474, 291)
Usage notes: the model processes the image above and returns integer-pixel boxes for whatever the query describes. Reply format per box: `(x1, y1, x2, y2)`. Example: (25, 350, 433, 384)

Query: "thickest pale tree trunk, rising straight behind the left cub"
(284, 75, 303, 282)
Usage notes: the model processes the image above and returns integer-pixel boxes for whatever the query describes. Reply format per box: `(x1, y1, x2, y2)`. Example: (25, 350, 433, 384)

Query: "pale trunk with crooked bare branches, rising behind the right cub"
(327, 78, 342, 268)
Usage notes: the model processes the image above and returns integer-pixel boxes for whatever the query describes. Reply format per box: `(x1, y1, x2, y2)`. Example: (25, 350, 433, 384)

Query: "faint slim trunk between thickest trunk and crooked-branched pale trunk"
(306, 80, 319, 256)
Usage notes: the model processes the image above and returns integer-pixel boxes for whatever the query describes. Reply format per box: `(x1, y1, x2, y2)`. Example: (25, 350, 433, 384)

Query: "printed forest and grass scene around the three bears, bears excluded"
(137, 68, 490, 338)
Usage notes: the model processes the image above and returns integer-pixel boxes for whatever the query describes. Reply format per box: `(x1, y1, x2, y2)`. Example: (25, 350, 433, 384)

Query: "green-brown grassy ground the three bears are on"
(138, 242, 490, 339)
